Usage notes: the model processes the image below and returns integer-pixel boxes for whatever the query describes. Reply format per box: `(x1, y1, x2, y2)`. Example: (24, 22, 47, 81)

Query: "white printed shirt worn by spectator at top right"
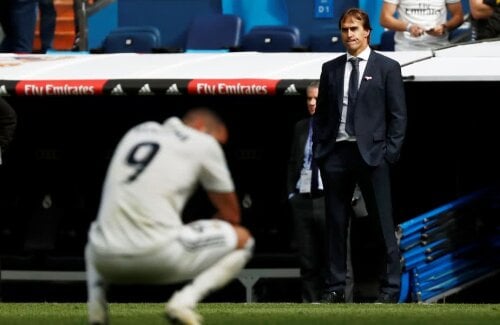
(384, 0, 460, 51)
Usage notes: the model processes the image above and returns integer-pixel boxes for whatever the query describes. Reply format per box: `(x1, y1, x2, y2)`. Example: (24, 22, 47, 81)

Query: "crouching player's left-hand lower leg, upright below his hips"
(85, 244, 108, 325)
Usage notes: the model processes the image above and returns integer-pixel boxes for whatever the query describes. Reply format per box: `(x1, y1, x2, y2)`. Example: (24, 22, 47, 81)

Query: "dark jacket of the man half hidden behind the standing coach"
(287, 117, 311, 193)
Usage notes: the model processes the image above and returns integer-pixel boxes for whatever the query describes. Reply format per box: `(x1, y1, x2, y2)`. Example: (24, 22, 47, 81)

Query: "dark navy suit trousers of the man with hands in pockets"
(319, 141, 401, 294)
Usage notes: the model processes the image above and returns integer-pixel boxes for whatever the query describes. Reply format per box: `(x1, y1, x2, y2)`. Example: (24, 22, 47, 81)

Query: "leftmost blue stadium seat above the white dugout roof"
(96, 26, 161, 53)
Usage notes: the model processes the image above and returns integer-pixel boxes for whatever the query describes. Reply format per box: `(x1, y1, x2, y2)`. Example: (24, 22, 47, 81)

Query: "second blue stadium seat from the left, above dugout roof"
(185, 14, 242, 52)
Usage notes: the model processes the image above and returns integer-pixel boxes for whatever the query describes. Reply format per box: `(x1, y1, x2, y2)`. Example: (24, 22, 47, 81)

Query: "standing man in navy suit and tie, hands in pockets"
(313, 8, 407, 303)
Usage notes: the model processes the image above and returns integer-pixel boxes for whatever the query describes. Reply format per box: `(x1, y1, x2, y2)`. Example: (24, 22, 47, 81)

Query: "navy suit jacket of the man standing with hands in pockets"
(313, 50, 407, 166)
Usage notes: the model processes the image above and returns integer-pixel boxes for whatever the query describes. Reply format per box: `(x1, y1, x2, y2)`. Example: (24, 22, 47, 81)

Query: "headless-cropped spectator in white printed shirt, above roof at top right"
(380, 0, 464, 51)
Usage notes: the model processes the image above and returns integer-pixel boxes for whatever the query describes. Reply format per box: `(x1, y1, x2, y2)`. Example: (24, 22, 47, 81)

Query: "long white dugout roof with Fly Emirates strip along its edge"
(0, 40, 500, 96)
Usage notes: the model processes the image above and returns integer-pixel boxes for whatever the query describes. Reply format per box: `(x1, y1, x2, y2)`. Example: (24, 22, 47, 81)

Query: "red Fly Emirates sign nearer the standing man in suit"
(188, 79, 277, 95)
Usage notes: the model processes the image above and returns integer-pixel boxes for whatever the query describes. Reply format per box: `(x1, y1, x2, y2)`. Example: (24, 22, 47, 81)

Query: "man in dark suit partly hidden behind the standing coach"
(287, 81, 353, 303)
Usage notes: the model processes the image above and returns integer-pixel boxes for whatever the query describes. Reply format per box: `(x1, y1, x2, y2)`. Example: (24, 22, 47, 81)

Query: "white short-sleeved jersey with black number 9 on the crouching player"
(89, 117, 234, 254)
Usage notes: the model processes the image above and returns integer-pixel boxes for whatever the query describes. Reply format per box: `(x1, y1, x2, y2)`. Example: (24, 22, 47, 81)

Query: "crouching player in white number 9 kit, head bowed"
(85, 108, 254, 324)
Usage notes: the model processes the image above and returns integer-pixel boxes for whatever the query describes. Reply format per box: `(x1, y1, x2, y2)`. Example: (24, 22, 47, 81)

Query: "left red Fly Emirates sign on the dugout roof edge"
(16, 80, 105, 96)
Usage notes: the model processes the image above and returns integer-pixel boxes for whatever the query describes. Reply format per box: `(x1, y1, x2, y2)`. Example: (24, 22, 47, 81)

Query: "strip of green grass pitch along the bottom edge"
(0, 303, 500, 325)
